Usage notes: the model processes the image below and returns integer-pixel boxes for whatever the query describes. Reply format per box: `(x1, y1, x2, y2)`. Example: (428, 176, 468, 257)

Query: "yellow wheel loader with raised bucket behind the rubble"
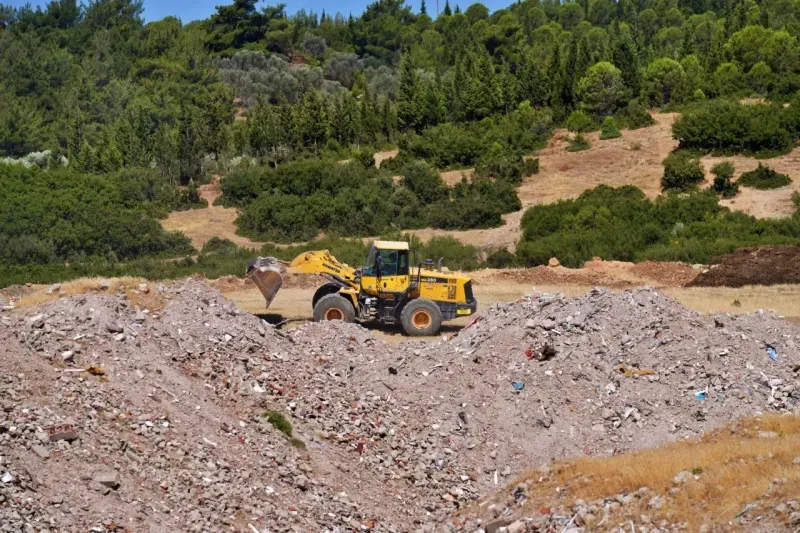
(247, 241, 478, 336)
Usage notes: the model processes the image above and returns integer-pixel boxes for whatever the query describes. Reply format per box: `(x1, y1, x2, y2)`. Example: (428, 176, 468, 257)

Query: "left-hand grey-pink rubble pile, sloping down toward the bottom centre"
(0, 281, 391, 532)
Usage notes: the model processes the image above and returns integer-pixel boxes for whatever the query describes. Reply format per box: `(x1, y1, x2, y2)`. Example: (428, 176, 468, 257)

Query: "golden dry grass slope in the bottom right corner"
(476, 415, 800, 531)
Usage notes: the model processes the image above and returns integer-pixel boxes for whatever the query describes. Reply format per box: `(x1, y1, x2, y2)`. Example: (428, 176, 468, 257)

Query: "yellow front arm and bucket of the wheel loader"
(247, 250, 359, 307)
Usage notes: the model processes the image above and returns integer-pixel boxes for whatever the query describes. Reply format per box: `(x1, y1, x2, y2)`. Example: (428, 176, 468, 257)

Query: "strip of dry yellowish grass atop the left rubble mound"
(15, 277, 166, 311)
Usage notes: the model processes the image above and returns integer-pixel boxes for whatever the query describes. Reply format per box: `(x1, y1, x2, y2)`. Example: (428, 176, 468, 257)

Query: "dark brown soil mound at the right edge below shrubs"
(689, 246, 800, 287)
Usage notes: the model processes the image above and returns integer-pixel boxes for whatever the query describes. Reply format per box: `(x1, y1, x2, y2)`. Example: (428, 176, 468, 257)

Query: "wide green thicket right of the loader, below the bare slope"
(517, 185, 800, 267)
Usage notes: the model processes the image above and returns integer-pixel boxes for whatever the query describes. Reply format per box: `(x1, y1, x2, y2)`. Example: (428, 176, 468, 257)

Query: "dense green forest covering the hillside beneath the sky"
(0, 0, 800, 282)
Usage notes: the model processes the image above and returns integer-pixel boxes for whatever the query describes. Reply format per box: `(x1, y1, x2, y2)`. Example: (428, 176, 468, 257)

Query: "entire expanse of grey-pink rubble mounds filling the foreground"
(0, 279, 800, 533)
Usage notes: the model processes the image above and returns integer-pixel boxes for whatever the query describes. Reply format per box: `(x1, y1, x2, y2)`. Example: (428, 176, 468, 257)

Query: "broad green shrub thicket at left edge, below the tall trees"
(0, 164, 194, 265)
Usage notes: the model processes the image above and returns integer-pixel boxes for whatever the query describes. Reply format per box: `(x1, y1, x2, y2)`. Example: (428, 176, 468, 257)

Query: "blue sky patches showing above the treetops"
(2, 0, 504, 22)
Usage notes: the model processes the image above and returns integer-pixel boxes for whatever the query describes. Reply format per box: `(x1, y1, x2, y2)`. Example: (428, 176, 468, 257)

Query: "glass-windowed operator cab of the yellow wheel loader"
(361, 241, 411, 296)
